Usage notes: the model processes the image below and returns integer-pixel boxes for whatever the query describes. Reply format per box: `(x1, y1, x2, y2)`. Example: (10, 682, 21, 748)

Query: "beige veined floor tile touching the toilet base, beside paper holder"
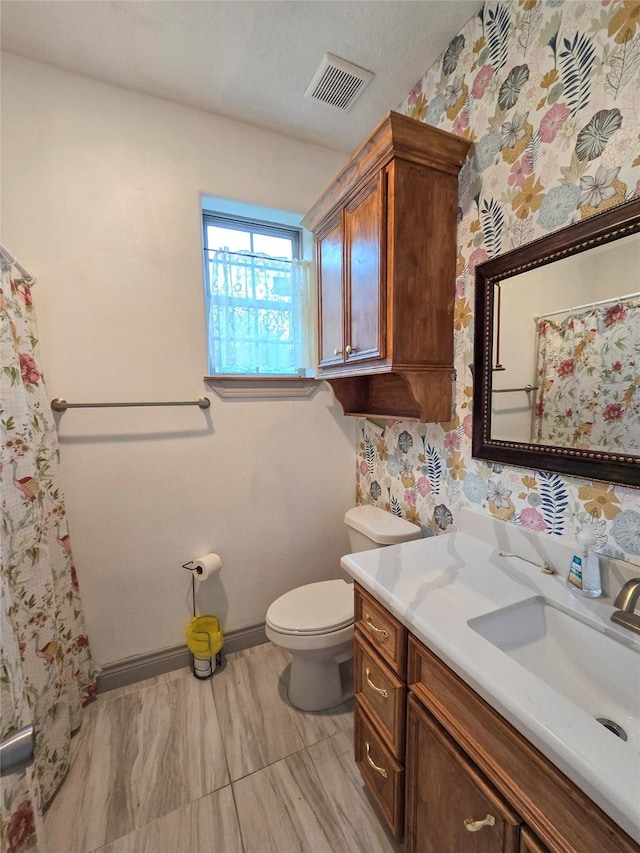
(210, 654, 304, 781)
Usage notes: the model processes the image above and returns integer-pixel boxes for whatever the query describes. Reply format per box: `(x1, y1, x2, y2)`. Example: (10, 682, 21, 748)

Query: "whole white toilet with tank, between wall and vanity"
(265, 505, 422, 711)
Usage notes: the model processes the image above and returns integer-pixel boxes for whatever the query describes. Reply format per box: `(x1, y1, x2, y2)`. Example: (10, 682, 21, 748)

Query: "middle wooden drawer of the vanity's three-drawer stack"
(354, 631, 407, 761)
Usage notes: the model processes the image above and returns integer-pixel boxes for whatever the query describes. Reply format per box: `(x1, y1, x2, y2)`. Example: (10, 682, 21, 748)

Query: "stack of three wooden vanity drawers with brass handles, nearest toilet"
(354, 584, 407, 841)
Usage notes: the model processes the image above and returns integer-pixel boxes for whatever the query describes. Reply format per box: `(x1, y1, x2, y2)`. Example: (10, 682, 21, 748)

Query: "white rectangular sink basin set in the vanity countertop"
(467, 596, 640, 751)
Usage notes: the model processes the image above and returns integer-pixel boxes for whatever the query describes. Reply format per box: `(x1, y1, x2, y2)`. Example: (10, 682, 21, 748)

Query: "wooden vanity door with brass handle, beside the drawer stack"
(406, 696, 520, 853)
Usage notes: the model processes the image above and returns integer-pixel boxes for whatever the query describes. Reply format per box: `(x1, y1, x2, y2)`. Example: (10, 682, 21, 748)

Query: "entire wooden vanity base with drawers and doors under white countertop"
(354, 583, 640, 853)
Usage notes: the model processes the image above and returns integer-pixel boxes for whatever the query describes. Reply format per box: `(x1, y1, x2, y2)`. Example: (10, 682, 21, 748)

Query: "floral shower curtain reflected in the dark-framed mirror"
(533, 296, 640, 452)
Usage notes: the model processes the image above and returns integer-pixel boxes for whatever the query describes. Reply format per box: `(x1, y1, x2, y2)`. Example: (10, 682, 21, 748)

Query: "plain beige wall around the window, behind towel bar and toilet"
(2, 55, 355, 665)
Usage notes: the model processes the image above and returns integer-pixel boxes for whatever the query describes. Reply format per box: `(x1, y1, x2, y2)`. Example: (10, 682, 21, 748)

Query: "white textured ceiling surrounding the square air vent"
(0, 0, 480, 153)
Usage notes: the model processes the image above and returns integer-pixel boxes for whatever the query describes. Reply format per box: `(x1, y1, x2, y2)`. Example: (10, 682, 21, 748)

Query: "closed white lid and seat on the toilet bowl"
(267, 580, 353, 634)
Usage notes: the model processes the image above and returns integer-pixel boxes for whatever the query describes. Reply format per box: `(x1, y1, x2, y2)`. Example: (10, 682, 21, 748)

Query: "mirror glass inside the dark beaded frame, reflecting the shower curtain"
(491, 234, 640, 455)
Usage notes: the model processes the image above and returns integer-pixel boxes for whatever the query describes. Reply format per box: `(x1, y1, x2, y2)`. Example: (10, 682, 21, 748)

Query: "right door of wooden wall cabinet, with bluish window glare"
(345, 172, 386, 364)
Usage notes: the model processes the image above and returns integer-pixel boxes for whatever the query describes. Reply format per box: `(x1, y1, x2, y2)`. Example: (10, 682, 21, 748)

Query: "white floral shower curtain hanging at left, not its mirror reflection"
(0, 262, 96, 853)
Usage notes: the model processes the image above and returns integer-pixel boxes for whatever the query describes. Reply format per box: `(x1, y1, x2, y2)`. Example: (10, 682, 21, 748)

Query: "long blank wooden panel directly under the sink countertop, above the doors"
(408, 636, 640, 853)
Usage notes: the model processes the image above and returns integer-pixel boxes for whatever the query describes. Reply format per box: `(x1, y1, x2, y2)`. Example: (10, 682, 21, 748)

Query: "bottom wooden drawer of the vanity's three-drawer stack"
(354, 705, 404, 841)
